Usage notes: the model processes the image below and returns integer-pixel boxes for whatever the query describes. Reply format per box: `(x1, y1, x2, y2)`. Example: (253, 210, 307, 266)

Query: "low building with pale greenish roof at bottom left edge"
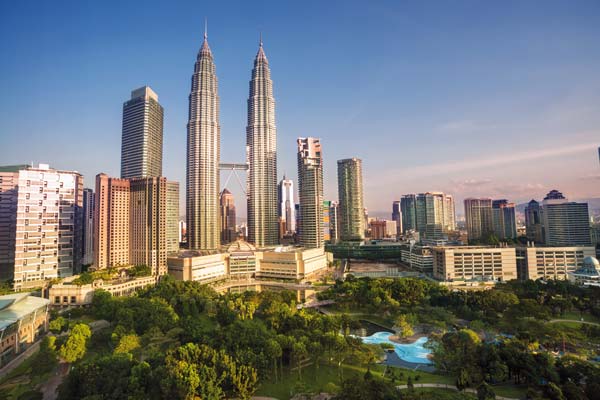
(0, 293, 49, 367)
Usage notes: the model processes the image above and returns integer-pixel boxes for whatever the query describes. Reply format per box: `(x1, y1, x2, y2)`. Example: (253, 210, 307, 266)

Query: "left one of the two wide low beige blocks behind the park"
(431, 246, 517, 281)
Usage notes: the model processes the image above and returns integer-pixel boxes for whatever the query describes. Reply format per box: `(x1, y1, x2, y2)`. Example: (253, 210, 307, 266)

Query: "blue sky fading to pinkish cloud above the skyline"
(0, 0, 600, 216)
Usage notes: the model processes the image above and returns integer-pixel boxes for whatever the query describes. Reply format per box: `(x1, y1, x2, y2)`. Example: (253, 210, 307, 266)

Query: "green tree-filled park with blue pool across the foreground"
(0, 276, 600, 400)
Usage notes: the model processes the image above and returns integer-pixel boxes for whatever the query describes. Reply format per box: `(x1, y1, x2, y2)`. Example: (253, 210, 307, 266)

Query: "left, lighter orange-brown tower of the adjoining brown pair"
(94, 174, 130, 269)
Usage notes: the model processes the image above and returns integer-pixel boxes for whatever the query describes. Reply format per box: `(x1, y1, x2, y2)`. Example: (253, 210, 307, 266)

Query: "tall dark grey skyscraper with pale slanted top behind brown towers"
(121, 86, 163, 178)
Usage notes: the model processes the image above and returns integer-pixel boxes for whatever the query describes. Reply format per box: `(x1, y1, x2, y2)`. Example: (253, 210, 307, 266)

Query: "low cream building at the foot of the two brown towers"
(48, 275, 158, 307)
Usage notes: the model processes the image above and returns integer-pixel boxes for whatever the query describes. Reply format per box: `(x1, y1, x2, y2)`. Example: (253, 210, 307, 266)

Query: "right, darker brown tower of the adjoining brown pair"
(129, 177, 167, 275)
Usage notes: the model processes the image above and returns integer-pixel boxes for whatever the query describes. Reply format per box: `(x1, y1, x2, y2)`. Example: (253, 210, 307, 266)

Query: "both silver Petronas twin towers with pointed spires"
(186, 33, 278, 251)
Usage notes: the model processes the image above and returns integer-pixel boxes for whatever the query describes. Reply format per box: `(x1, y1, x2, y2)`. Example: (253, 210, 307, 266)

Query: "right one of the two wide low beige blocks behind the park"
(516, 246, 596, 280)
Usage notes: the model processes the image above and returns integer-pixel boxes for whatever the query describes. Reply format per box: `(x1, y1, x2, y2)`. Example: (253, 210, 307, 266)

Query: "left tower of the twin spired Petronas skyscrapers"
(186, 32, 221, 250)
